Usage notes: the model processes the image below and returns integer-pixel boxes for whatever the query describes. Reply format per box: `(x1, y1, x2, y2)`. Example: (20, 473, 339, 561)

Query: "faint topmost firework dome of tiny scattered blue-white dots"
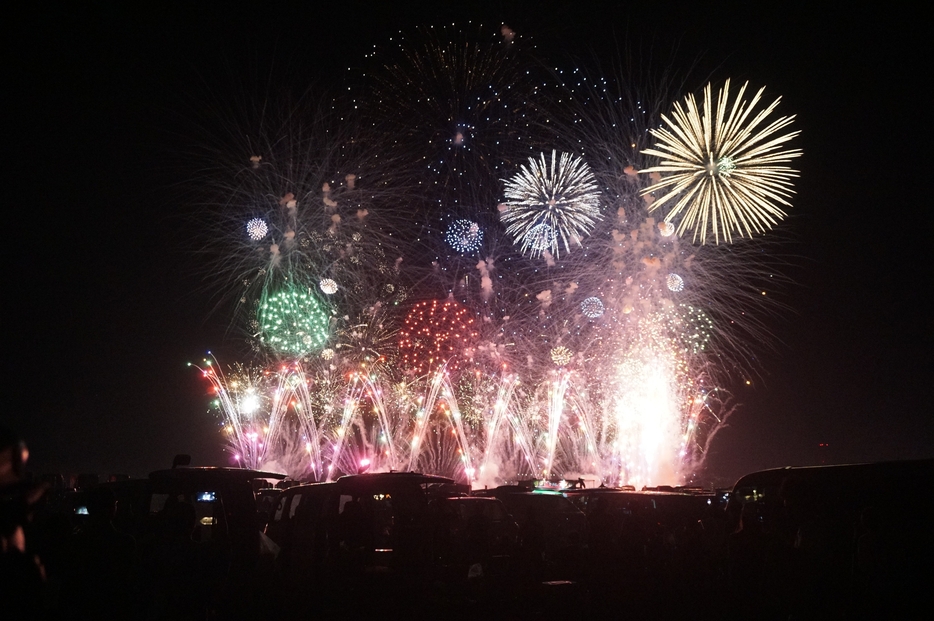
(354, 26, 544, 203)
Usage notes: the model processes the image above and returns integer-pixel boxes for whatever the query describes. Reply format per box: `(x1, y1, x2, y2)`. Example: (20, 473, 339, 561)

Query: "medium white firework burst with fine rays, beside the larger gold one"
(500, 151, 601, 257)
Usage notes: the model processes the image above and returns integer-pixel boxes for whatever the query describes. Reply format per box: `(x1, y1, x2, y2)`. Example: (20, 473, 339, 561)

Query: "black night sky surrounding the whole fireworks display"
(0, 2, 934, 483)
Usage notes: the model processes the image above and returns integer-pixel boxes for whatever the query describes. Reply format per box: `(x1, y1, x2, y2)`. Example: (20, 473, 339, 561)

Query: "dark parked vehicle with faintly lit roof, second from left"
(266, 472, 467, 613)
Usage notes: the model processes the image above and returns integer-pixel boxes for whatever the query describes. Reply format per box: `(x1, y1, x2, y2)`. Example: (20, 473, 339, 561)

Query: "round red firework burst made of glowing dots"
(399, 300, 478, 375)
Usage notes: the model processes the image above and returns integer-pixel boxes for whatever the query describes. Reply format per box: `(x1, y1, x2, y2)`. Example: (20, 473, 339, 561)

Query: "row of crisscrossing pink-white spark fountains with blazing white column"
(199, 344, 708, 487)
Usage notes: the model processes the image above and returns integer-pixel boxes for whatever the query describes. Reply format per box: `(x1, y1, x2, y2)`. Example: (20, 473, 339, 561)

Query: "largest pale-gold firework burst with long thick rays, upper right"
(640, 80, 801, 244)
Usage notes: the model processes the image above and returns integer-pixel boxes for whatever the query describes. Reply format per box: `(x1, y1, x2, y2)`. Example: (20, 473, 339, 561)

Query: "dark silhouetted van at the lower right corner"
(727, 459, 934, 618)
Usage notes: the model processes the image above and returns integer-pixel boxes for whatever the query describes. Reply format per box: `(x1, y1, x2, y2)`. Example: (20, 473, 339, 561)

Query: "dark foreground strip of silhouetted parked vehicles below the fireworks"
(0, 460, 934, 620)
